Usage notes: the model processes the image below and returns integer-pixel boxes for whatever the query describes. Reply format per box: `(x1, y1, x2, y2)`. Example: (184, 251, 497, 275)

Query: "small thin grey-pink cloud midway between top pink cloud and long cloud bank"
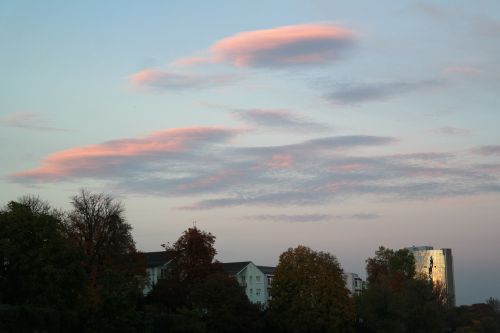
(232, 109, 330, 132)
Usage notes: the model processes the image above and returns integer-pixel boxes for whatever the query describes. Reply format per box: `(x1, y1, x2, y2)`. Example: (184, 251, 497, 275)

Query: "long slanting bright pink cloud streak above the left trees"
(11, 127, 237, 181)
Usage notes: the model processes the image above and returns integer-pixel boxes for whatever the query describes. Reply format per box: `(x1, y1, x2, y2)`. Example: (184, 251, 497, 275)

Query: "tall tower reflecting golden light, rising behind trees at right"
(407, 246, 455, 306)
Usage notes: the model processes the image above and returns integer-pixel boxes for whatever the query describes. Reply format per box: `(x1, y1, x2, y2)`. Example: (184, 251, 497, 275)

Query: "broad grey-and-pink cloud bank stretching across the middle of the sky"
(11, 127, 500, 209)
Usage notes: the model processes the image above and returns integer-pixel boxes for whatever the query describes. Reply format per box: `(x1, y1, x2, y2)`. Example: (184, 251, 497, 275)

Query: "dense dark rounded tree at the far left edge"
(0, 200, 84, 310)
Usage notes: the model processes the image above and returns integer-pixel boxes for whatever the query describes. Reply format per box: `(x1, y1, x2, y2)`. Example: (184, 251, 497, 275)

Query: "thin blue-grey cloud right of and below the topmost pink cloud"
(325, 80, 442, 105)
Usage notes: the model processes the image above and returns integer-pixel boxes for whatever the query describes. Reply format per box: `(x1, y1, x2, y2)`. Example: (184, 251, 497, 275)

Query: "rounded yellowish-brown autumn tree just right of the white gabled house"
(269, 246, 354, 332)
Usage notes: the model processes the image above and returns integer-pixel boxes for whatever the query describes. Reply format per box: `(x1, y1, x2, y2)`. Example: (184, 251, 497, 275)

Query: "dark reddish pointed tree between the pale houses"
(146, 227, 262, 333)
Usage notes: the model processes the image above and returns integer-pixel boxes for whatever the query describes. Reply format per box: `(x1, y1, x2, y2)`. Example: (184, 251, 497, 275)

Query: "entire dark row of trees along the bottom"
(0, 190, 500, 333)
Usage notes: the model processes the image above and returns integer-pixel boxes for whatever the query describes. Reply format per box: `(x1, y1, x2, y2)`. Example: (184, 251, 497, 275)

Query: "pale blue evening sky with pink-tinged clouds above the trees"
(0, 0, 500, 304)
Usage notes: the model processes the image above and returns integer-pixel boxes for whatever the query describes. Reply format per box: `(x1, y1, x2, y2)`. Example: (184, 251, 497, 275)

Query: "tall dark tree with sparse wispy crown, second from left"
(66, 190, 146, 332)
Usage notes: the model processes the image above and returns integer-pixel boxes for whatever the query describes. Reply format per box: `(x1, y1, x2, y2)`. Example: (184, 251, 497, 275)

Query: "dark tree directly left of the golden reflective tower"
(356, 247, 446, 332)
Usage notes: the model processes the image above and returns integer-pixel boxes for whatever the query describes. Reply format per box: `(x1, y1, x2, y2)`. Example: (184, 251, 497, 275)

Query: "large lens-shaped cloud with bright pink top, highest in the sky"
(176, 23, 356, 68)
